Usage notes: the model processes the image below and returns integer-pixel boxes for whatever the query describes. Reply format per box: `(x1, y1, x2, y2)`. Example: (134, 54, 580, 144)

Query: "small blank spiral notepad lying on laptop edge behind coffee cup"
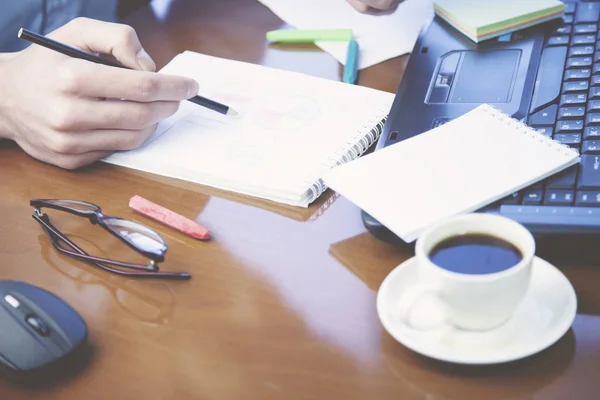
(324, 104, 580, 243)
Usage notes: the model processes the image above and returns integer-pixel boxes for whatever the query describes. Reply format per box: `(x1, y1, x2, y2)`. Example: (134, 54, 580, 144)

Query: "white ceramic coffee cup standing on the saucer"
(401, 213, 535, 331)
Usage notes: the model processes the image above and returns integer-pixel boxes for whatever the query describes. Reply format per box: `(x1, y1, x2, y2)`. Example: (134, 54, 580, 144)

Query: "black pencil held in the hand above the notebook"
(17, 28, 237, 115)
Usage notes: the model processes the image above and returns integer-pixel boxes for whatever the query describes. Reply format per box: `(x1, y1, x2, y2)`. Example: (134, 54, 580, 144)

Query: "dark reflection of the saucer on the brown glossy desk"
(381, 330, 576, 400)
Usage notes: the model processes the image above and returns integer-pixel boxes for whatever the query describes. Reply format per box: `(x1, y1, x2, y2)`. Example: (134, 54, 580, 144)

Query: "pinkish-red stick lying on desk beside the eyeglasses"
(129, 196, 210, 239)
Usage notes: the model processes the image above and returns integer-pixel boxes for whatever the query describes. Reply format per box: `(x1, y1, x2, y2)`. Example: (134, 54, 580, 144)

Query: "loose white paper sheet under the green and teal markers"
(259, 0, 433, 69)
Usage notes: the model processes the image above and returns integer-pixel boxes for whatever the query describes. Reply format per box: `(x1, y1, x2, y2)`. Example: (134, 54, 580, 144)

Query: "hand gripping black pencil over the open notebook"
(0, 18, 198, 169)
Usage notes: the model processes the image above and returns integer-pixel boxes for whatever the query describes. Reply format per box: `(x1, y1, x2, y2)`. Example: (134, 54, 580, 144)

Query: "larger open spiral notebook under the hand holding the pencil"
(103, 51, 394, 207)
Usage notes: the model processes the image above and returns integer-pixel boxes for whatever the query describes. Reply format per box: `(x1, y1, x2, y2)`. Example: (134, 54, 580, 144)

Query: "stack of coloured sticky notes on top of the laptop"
(434, 0, 564, 43)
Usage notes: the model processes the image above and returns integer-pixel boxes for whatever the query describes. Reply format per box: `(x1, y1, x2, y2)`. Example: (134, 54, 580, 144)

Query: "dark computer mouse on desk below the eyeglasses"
(0, 280, 88, 380)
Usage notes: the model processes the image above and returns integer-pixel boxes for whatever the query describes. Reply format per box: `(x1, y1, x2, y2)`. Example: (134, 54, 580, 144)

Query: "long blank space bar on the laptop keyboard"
(531, 46, 568, 110)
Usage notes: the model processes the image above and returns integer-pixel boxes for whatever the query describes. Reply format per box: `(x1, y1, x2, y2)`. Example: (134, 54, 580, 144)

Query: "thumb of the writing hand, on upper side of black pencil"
(48, 18, 156, 71)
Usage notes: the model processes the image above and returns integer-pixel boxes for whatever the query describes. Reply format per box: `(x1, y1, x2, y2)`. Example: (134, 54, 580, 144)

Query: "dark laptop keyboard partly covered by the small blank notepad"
(502, 2, 600, 207)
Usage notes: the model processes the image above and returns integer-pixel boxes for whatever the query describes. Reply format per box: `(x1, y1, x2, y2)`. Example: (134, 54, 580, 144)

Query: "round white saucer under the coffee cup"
(377, 257, 577, 364)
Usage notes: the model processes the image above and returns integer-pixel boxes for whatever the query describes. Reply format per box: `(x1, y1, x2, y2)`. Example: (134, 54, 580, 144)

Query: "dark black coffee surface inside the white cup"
(429, 234, 523, 274)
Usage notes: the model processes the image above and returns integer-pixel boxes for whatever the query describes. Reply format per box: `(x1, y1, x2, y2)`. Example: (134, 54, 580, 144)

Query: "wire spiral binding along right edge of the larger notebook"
(304, 110, 388, 203)
